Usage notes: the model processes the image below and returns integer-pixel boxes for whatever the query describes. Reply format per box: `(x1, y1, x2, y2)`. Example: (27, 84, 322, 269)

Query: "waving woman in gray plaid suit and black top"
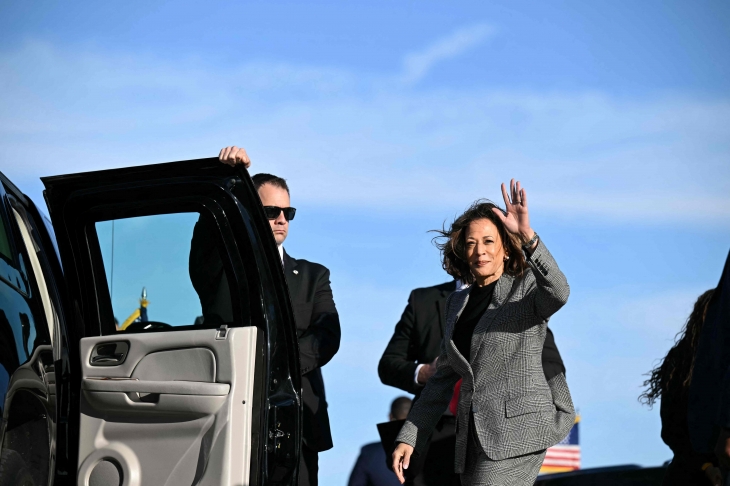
(393, 180, 575, 486)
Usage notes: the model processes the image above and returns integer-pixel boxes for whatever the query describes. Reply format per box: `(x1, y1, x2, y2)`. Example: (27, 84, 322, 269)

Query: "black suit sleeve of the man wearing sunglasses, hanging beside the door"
(299, 267, 341, 374)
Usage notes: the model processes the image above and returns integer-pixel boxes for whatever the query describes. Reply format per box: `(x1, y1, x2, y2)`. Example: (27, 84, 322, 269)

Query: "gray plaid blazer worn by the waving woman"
(396, 240, 575, 473)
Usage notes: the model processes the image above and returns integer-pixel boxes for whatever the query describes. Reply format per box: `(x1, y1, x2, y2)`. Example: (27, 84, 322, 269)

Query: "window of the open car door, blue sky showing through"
(95, 212, 240, 332)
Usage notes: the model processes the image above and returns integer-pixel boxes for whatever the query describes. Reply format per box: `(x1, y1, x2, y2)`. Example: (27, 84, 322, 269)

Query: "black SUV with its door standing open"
(0, 159, 301, 486)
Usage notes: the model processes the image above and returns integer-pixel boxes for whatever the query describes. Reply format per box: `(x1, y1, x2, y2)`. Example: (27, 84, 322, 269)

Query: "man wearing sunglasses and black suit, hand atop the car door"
(218, 147, 340, 486)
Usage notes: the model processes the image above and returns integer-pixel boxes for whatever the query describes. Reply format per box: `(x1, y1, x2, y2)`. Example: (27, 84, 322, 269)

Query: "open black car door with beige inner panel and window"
(43, 159, 301, 486)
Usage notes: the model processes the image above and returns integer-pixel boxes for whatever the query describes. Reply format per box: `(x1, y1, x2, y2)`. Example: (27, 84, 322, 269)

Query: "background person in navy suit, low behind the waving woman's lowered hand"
(347, 397, 411, 486)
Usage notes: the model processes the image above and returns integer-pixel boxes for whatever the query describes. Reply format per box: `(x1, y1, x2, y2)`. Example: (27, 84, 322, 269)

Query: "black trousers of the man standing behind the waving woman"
(405, 415, 461, 486)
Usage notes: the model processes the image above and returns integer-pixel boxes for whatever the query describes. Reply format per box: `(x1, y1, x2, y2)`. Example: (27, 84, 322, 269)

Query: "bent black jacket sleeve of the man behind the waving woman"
(378, 292, 422, 393)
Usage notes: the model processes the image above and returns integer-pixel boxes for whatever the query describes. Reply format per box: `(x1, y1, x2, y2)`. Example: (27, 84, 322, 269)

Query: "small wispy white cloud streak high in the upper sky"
(401, 24, 495, 83)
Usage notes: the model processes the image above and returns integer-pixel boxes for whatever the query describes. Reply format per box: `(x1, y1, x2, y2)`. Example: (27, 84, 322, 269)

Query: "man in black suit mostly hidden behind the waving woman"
(378, 280, 565, 486)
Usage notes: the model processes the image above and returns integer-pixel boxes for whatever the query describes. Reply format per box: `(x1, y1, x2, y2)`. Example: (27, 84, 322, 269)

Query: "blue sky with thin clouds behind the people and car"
(0, 1, 730, 486)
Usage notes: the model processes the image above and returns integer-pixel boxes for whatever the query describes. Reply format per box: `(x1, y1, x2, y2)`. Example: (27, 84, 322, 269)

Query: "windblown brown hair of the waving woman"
(432, 199, 527, 284)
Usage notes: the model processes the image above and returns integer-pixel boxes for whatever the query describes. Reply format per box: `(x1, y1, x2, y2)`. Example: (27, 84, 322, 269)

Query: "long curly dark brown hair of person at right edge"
(639, 289, 715, 407)
